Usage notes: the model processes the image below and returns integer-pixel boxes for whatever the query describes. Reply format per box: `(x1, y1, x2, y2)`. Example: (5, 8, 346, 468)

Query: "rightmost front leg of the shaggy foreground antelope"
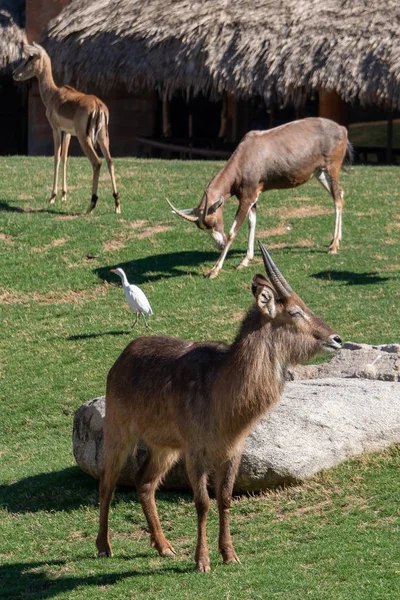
(215, 452, 241, 564)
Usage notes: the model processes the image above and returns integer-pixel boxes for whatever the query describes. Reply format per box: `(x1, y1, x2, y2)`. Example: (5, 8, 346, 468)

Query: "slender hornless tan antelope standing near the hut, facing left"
(13, 42, 121, 213)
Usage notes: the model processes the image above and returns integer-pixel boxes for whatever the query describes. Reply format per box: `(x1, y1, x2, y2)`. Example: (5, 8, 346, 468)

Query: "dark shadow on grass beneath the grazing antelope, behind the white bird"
(94, 250, 243, 285)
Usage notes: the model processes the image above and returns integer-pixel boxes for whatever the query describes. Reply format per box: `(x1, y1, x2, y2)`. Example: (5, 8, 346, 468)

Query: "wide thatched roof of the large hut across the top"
(45, 0, 400, 108)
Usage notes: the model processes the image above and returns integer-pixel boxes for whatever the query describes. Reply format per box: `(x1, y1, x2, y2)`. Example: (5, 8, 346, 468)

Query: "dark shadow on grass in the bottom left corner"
(0, 549, 187, 600)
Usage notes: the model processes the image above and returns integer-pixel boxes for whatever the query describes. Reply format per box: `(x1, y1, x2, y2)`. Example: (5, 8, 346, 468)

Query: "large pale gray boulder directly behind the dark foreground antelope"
(73, 378, 400, 492)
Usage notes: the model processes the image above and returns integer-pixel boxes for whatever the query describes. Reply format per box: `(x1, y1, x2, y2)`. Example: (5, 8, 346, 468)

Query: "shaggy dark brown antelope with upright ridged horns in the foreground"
(96, 244, 342, 571)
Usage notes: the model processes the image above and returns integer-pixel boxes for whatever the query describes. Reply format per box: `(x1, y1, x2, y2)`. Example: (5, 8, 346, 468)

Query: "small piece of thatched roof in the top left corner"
(0, 0, 27, 73)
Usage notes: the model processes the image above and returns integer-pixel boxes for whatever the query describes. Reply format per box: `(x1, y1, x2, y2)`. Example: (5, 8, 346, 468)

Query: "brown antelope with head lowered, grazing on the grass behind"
(167, 118, 351, 278)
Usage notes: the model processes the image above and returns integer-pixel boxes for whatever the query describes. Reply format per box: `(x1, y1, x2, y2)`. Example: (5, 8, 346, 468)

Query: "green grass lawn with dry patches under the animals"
(0, 157, 400, 600)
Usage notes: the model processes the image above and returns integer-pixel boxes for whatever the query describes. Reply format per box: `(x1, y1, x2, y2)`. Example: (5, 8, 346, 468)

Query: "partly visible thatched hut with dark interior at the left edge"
(0, 0, 27, 154)
